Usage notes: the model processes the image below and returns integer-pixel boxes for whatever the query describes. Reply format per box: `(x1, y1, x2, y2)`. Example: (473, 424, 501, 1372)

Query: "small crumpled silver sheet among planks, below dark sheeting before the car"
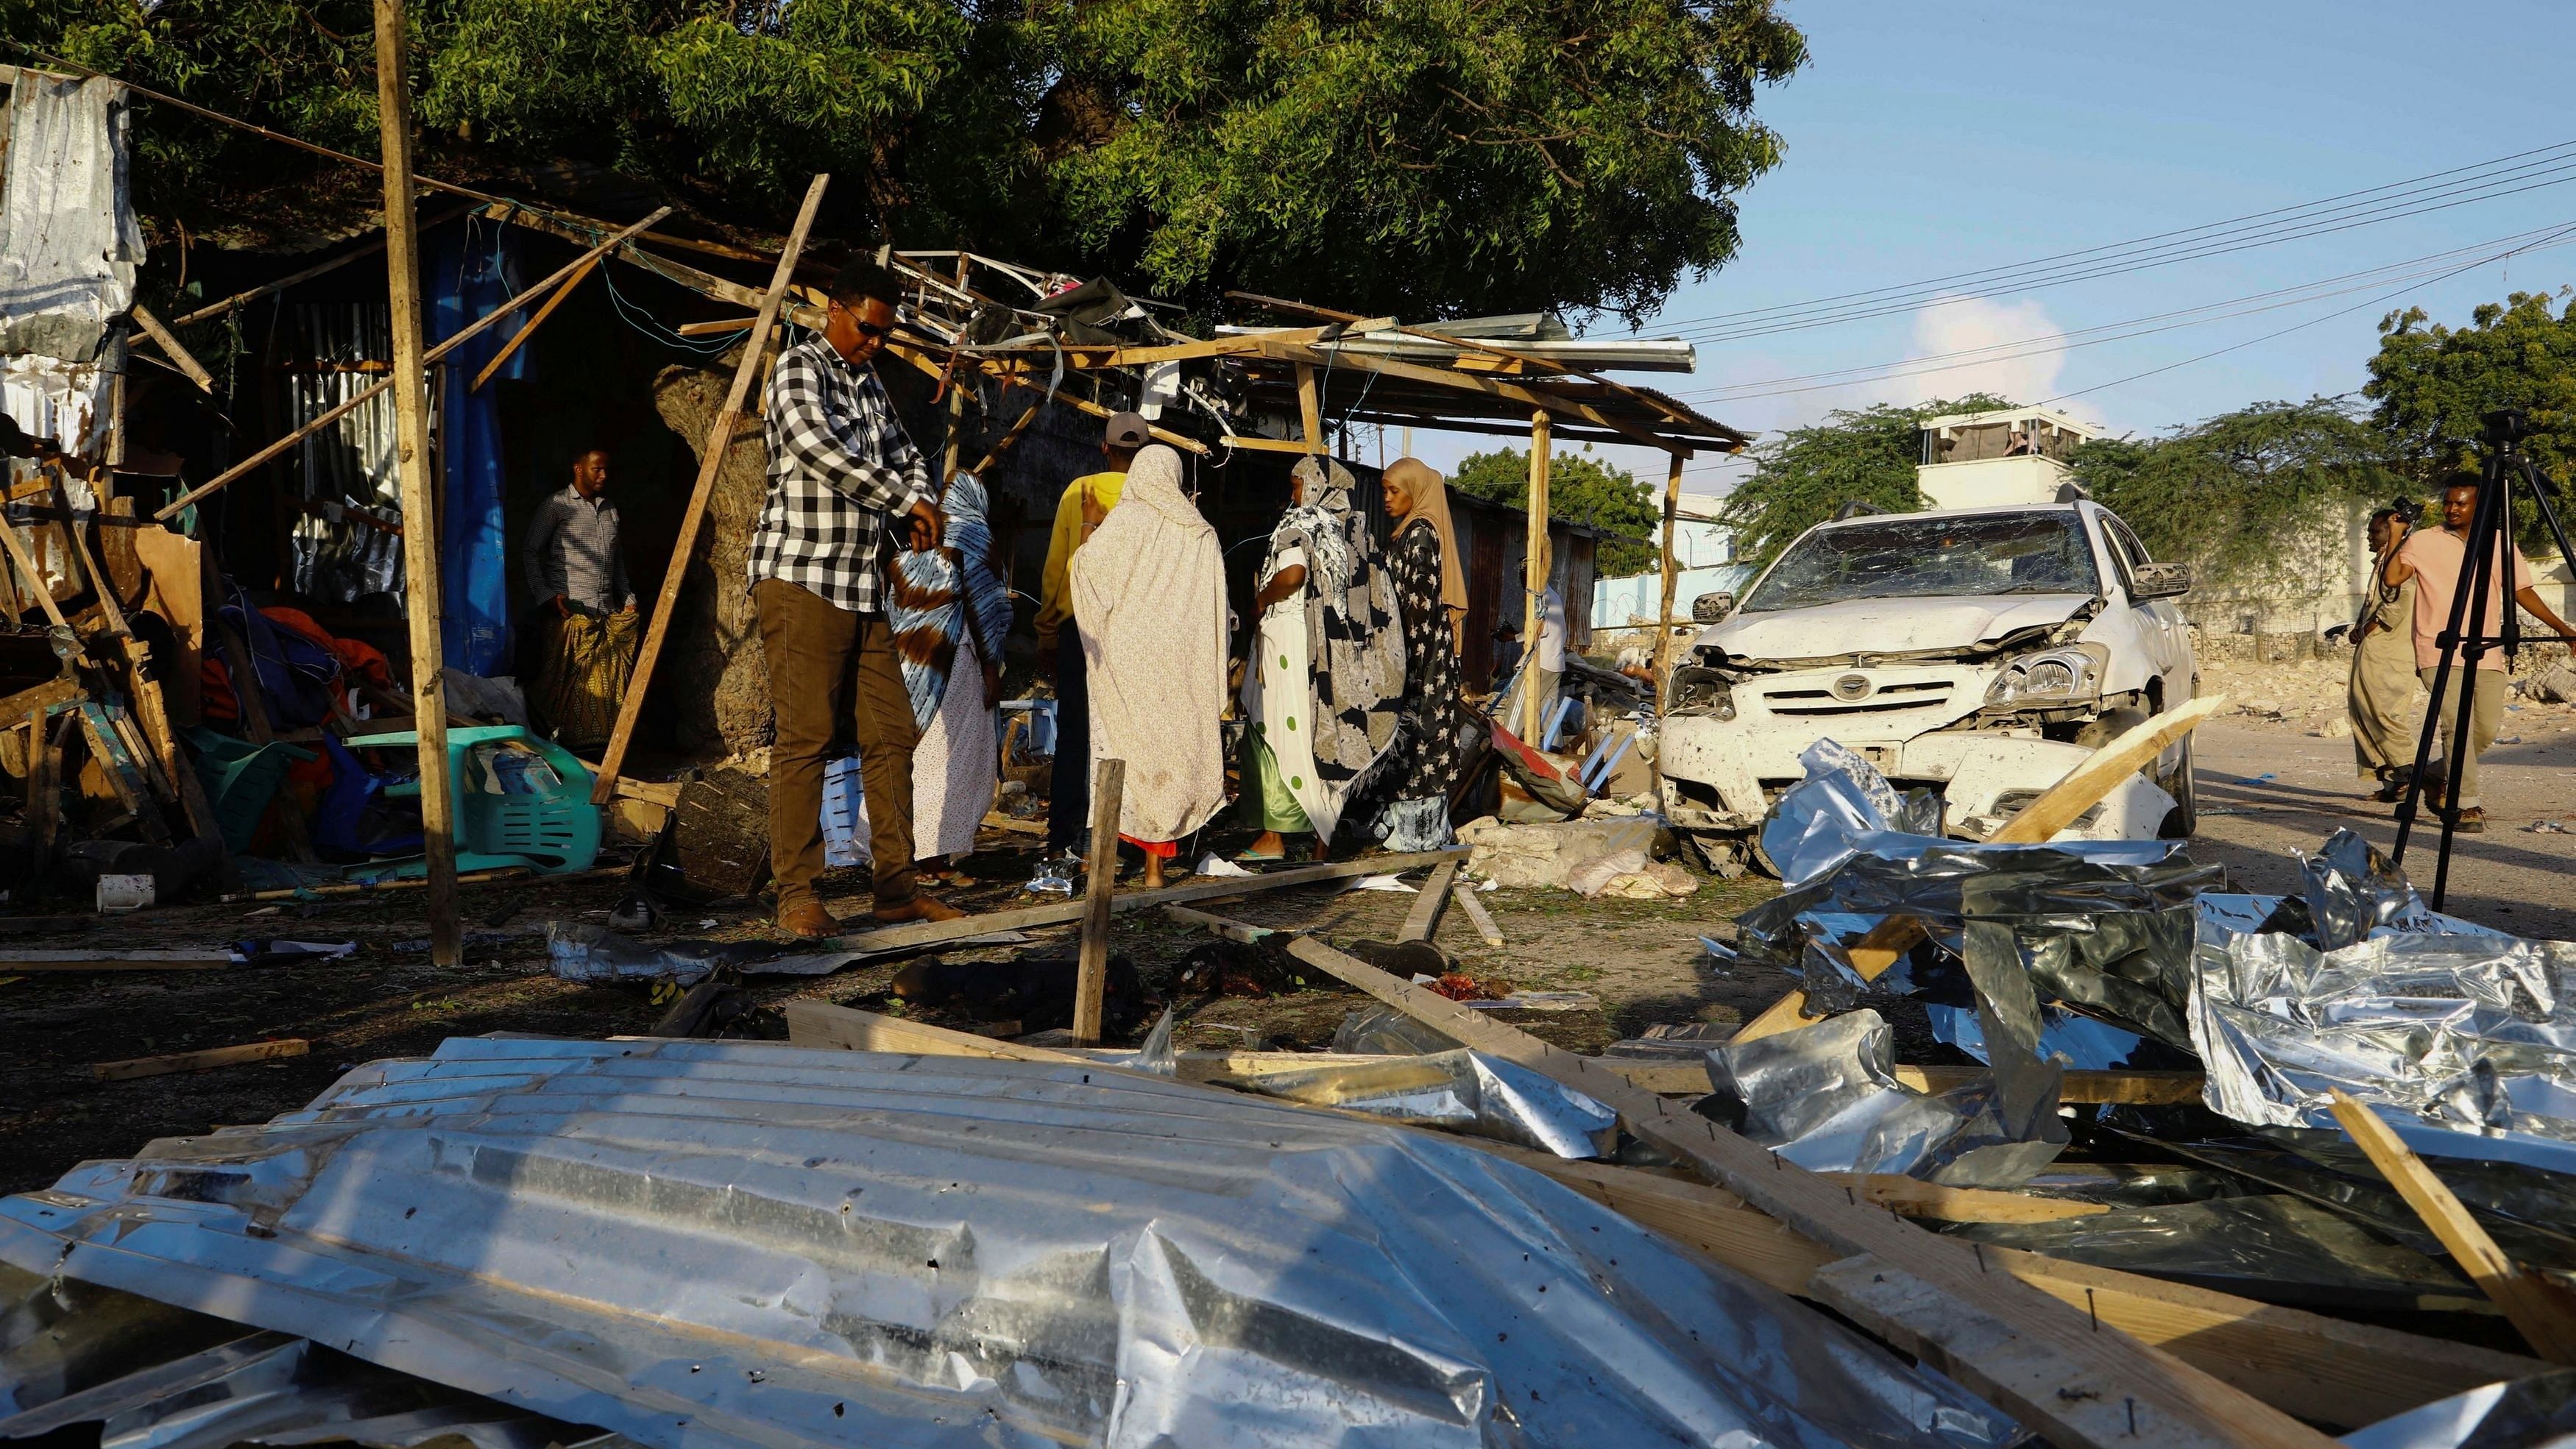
(1693, 1009, 2066, 1186)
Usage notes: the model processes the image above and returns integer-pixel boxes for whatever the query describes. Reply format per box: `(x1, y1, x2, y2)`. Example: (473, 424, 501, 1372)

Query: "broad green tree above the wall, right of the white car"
(2074, 397, 2406, 587)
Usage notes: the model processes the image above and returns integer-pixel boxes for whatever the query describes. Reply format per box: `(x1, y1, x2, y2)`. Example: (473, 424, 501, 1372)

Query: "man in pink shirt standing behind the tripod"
(2380, 474, 2576, 834)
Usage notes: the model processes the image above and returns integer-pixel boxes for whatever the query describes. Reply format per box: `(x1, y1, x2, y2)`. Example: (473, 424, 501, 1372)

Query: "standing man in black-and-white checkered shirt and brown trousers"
(750, 260, 958, 937)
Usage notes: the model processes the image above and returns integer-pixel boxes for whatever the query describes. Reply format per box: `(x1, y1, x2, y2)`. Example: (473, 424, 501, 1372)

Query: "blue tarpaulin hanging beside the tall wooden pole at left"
(428, 222, 528, 677)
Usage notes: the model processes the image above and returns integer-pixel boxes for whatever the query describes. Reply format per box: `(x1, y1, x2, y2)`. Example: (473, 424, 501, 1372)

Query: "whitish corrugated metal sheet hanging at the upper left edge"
(0, 72, 144, 363)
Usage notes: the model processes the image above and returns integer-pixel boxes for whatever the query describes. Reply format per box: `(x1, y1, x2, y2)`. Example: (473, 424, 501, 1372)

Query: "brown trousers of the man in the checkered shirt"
(752, 579, 920, 906)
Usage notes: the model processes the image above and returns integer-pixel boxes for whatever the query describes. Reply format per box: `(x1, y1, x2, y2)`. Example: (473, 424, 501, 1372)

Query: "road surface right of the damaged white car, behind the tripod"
(2193, 710, 2576, 940)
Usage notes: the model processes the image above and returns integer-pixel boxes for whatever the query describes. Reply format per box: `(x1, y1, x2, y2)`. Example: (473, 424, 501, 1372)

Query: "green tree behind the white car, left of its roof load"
(1719, 394, 2012, 566)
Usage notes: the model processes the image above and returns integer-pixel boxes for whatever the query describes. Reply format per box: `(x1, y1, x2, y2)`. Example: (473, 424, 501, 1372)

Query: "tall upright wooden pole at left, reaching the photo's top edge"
(376, 0, 464, 968)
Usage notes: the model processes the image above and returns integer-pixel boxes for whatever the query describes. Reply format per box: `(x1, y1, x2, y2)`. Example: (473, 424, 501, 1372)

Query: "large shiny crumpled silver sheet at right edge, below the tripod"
(2190, 842, 2576, 1171)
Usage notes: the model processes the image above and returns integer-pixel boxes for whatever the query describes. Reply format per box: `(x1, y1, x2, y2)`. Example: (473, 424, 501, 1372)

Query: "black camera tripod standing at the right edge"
(2373, 407, 2576, 911)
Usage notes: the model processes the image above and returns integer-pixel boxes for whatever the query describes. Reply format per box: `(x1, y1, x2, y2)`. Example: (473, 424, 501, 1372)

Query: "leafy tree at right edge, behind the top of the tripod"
(2363, 291, 2576, 499)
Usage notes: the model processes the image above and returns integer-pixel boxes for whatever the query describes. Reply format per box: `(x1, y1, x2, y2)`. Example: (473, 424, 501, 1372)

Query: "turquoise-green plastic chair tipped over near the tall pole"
(340, 726, 601, 880)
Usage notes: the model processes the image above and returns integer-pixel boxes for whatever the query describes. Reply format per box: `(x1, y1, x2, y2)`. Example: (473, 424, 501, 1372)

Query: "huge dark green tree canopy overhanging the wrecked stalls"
(0, 0, 1806, 316)
